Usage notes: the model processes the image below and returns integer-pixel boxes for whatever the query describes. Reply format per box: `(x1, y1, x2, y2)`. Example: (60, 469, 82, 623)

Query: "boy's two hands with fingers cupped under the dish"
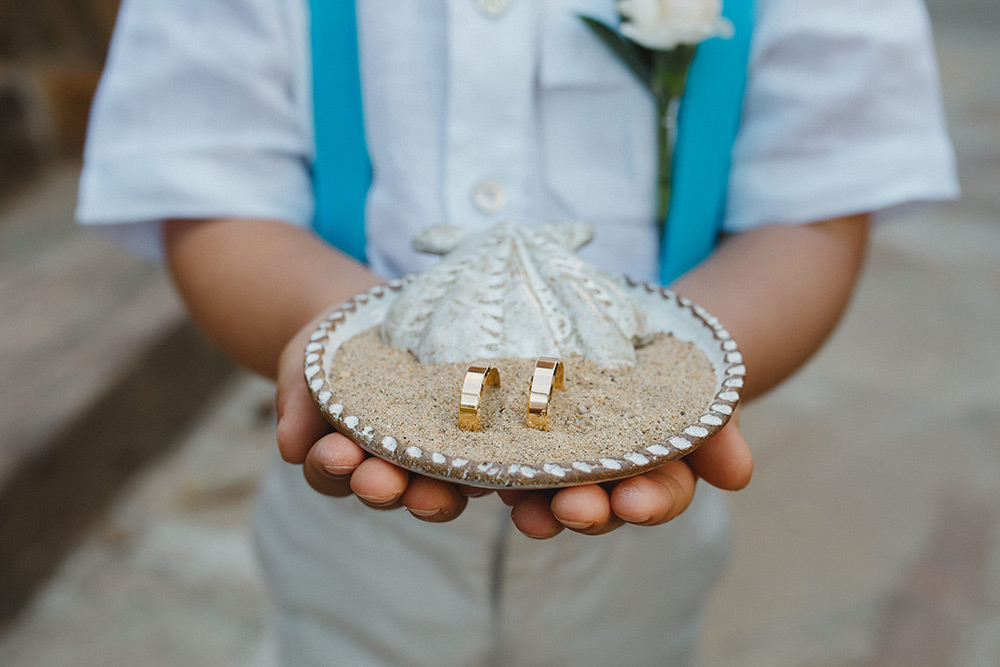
(277, 314, 753, 539)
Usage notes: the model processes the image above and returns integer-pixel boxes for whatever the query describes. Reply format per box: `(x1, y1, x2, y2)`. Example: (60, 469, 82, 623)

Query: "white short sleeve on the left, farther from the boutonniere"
(77, 0, 313, 256)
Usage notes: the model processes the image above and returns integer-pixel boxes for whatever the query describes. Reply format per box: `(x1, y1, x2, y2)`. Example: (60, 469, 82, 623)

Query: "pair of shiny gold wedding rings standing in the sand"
(458, 357, 566, 431)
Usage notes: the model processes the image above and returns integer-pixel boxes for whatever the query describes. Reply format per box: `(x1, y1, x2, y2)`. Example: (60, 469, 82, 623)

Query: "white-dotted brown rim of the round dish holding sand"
(305, 278, 746, 489)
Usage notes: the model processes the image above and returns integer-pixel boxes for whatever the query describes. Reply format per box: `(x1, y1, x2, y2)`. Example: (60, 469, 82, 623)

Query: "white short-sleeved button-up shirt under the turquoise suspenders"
(78, 0, 957, 279)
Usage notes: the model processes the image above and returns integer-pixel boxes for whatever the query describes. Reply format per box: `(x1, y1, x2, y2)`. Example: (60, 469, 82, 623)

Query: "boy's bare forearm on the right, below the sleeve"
(673, 215, 869, 398)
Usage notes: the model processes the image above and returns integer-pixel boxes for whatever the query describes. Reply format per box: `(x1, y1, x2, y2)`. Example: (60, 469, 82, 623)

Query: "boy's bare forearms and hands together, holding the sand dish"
(165, 217, 868, 537)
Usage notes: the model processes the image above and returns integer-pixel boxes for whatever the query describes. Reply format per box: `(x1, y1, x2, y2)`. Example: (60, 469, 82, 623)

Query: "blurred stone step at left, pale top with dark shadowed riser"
(0, 163, 233, 625)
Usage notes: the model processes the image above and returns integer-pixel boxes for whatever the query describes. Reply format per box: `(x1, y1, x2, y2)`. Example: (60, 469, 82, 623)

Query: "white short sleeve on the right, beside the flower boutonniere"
(725, 0, 958, 232)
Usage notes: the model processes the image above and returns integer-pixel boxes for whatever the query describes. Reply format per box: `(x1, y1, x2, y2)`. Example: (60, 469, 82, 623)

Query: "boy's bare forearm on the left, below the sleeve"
(164, 219, 380, 378)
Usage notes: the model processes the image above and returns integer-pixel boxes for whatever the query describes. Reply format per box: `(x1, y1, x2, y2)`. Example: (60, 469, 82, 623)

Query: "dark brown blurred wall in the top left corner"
(0, 0, 118, 197)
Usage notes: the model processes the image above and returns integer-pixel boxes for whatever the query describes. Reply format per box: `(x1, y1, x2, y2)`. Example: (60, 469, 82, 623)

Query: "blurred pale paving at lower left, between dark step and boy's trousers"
(0, 375, 276, 667)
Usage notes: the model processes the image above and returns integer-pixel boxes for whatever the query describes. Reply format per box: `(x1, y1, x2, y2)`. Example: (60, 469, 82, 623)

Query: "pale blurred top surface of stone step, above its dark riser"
(0, 163, 183, 486)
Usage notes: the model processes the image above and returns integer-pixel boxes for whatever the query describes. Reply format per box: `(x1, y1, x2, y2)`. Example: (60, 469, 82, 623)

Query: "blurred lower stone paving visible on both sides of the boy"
(0, 0, 1000, 667)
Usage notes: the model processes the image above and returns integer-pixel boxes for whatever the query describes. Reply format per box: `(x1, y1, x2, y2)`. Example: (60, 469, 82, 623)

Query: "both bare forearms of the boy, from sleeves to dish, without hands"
(164, 216, 868, 397)
